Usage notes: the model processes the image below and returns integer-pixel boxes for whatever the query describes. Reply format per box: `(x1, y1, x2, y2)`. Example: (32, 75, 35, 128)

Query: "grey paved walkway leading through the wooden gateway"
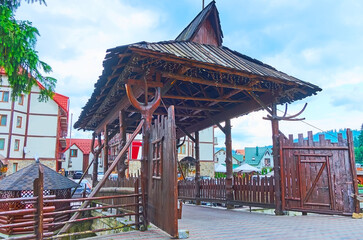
(87, 205, 363, 240)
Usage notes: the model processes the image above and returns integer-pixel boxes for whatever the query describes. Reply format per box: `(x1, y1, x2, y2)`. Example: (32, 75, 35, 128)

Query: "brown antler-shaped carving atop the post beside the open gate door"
(125, 84, 161, 126)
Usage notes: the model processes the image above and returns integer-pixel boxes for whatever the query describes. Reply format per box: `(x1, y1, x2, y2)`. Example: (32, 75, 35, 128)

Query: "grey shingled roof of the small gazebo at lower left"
(0, 163, 78, 191)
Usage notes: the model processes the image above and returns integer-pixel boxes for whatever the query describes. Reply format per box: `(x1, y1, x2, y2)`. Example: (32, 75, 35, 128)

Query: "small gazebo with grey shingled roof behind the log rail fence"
(0, 162, 78, 235)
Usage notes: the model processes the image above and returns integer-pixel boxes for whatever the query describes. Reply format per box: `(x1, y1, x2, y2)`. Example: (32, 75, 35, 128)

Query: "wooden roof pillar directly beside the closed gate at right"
(271, 104, 284, 215)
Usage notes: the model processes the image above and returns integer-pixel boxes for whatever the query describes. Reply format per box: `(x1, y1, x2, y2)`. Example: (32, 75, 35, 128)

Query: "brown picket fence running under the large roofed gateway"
(178, 175, 275, 207)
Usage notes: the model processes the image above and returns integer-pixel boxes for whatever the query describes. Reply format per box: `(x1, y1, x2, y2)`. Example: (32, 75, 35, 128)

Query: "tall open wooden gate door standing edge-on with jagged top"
(147, 106, 178, 237)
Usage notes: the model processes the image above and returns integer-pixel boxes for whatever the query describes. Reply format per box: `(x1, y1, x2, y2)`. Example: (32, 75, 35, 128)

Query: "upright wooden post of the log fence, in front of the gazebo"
(33, 164, 44, 240)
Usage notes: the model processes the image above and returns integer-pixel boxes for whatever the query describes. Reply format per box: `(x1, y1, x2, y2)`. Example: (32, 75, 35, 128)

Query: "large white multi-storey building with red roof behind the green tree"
(0, 70, 69, 175)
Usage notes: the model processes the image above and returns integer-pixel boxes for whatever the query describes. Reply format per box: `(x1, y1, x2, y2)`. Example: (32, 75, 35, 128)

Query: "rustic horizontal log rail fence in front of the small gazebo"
(0, 165, 141, 240)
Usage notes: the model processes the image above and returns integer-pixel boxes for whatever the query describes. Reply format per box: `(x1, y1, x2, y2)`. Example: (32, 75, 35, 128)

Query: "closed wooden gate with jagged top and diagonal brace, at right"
(280, 130, 359, 215)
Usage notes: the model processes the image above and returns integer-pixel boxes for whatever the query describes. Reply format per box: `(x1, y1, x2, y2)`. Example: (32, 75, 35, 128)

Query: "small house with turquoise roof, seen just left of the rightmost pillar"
(245, 147, 274, 169)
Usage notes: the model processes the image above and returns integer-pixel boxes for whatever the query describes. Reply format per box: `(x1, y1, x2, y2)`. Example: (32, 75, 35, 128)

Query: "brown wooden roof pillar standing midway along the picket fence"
(224, 119, 233, 209)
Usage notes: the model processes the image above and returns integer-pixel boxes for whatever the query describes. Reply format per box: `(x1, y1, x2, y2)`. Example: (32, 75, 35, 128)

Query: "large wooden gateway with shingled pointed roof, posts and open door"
(74, 1, 321, 237)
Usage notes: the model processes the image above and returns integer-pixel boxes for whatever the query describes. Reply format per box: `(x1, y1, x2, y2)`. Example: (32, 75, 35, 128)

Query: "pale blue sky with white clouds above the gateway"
(16, 0, 363, 149)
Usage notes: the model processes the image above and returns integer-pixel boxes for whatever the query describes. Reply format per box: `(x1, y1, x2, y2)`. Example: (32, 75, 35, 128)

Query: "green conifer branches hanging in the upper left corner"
(0, 0, 57, 100)
